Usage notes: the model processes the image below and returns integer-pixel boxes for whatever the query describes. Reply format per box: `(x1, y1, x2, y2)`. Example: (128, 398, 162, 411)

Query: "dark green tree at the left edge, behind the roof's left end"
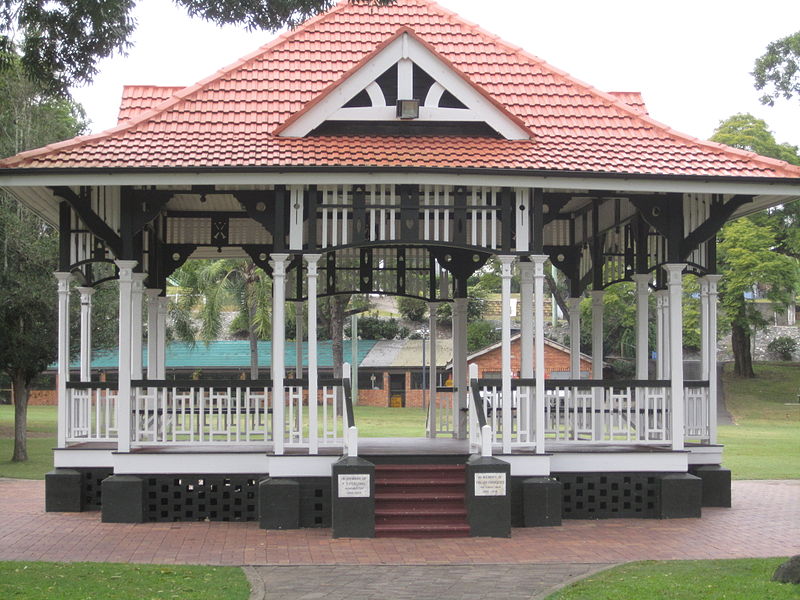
(0, 54, 85, 461)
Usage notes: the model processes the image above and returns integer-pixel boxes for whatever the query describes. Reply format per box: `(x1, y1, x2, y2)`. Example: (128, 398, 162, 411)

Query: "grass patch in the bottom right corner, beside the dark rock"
(548, 558, 797, 600)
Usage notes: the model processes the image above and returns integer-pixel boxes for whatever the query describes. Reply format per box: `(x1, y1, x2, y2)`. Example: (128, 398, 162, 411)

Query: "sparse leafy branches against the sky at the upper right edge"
(752, 31, 800, 106)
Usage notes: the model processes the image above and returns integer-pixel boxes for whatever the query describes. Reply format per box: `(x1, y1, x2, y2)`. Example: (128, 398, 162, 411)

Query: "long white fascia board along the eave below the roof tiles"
(6, 168, 800, 196)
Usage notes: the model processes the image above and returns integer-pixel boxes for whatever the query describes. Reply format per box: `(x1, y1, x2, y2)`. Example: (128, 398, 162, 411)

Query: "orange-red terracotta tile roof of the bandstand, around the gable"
(0, 0, 800, 177)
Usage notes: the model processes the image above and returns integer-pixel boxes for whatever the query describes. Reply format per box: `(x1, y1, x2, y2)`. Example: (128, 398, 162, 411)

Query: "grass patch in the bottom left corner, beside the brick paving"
(0, 562, 250, 600)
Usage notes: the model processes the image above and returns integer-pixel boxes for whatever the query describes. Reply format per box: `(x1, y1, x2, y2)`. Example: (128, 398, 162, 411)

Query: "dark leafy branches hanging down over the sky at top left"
(0, 0, 393, 93)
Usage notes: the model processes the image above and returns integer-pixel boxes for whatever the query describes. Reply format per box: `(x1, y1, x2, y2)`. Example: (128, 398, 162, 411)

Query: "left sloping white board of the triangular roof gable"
(280, 36, 404, 137)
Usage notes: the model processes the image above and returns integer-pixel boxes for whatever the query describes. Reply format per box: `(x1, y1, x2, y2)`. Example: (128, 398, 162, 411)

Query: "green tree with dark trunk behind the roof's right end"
(711, 114, 800, 377)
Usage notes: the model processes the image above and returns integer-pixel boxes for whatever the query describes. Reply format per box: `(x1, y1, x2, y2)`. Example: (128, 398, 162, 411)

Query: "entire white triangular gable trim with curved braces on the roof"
(275, 28, 531, 140)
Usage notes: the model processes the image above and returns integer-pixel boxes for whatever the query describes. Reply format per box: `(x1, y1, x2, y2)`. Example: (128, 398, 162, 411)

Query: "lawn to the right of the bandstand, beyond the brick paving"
(719, 363, 800, 479)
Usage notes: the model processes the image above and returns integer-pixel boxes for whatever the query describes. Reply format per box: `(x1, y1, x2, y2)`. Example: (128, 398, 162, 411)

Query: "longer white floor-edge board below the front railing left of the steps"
(113, 450, 269, 475)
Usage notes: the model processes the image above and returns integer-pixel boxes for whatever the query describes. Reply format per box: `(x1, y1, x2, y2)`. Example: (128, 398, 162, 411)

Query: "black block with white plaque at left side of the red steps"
(331, 457, 375, 538)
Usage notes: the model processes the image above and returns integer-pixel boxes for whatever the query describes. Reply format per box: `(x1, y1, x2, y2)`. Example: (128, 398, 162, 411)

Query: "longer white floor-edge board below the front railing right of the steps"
(550, 448, 689, 473)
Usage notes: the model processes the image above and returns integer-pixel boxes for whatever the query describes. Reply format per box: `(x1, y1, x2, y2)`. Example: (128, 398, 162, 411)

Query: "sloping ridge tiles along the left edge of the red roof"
(0, 0, 349, 167)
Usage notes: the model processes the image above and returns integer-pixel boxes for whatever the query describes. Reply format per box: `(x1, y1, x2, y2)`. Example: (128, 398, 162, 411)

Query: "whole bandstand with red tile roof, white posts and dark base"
(0, 0, 800, 536)
